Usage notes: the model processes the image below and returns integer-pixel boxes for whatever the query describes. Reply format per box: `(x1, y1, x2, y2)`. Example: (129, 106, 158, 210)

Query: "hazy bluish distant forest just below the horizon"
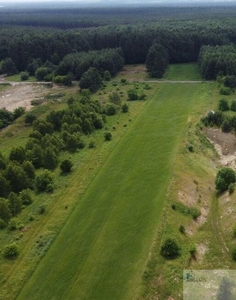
(0, 4, 235, 30)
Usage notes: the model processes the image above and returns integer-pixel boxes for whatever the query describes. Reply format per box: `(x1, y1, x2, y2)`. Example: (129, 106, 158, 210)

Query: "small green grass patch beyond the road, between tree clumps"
(163, 63, 203, 81)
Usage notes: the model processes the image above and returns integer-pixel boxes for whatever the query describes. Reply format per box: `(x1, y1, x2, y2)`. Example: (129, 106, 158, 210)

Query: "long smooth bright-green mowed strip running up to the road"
(17, 83, 202, 300)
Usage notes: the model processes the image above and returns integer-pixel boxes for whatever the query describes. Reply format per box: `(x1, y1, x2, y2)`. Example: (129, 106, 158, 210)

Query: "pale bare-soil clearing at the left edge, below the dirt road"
(0, 83, 47, 111)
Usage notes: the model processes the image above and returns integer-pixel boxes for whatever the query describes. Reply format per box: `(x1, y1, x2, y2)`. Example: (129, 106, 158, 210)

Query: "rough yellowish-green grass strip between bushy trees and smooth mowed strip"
(0, 88, 151, 300)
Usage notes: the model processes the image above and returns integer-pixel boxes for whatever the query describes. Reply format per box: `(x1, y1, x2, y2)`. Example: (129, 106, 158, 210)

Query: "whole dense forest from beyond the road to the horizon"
(0, 7, 236, 80)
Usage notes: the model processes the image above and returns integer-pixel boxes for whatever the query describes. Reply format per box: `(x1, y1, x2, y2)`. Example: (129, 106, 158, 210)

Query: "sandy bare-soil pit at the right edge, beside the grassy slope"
(204, 128, 236, 170)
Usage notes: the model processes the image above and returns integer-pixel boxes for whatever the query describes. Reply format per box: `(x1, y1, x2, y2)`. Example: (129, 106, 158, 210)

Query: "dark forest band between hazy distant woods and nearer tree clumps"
(0, 19, 236, 77)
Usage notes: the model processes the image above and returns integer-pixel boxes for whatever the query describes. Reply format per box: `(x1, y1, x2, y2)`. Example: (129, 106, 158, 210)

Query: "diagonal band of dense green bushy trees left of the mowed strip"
(0, 89, 123, 228)
